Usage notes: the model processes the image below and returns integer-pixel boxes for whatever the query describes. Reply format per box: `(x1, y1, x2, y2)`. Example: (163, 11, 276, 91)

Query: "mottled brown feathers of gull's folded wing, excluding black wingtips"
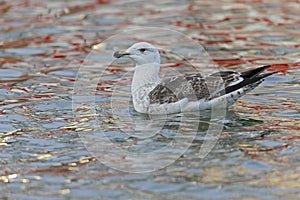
(149, 71, 238, 104)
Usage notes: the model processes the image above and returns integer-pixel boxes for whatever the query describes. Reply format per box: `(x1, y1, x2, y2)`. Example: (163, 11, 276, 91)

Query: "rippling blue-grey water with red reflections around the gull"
(0, 1, 300, 199)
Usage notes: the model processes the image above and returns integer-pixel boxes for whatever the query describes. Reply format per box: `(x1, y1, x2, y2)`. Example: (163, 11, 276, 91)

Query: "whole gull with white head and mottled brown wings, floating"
(113, 42, 277, 114)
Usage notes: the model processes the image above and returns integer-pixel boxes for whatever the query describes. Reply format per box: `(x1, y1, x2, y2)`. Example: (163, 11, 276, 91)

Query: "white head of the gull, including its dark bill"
(114, 42, 160, 65)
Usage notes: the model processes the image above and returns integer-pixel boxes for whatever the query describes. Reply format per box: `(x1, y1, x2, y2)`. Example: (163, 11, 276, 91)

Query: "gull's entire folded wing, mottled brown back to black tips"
(149, 65, 277, 104)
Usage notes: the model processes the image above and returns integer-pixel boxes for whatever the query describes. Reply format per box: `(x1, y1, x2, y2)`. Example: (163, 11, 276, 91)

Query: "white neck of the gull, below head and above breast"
(131, 63, 160, 92)
